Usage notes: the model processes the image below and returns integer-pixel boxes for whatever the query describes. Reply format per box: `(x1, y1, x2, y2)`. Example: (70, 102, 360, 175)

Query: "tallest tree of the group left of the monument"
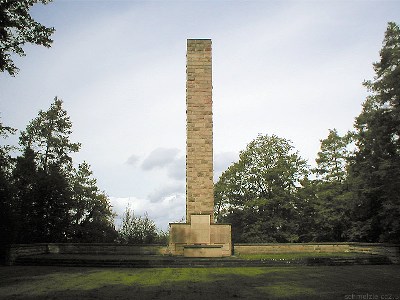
(14, 97, 80, 242)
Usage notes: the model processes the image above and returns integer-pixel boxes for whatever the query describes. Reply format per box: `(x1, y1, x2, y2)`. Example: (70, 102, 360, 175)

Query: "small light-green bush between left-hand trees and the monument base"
(119, 205, 157, 244)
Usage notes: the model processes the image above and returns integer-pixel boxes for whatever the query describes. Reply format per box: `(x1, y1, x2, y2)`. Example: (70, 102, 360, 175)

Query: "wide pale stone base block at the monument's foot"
(169, 215, 232, 257)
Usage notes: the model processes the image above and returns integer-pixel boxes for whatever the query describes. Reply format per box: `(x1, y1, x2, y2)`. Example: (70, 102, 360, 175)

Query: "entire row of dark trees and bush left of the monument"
(0, 98, 166, 262)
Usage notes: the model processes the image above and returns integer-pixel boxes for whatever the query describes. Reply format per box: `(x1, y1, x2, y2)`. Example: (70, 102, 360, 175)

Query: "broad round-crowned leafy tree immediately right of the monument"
(215, 135, 308, 242)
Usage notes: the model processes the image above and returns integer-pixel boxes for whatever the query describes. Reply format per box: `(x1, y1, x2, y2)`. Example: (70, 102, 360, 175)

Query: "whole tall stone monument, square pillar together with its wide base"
(169, 39, 232, 257)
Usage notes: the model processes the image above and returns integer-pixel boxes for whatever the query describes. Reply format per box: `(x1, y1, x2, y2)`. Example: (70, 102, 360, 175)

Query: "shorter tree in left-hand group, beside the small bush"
(70, 162, 117, 242)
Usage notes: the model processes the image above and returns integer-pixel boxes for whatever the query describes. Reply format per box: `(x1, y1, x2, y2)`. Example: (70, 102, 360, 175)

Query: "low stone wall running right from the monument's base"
(234, 243, 400, 263)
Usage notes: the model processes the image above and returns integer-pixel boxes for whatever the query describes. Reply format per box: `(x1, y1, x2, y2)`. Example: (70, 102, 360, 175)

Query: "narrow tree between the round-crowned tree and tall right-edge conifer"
(313, 129, 353, 242)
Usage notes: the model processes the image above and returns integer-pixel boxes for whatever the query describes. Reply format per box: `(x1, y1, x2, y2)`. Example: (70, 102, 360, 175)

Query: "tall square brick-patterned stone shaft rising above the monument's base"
(186, 39, 214, 223)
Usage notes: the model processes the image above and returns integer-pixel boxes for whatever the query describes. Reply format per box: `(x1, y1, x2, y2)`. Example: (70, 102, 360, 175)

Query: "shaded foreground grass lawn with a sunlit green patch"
(0, 265, 400, 299)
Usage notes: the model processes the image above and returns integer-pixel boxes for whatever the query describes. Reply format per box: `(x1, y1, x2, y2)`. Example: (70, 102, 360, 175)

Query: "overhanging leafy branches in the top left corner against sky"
(0, 0, 55, 76)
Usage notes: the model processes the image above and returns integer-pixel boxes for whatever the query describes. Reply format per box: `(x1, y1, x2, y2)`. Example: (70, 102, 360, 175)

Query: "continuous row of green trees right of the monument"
(215, 23, 400, 243)
